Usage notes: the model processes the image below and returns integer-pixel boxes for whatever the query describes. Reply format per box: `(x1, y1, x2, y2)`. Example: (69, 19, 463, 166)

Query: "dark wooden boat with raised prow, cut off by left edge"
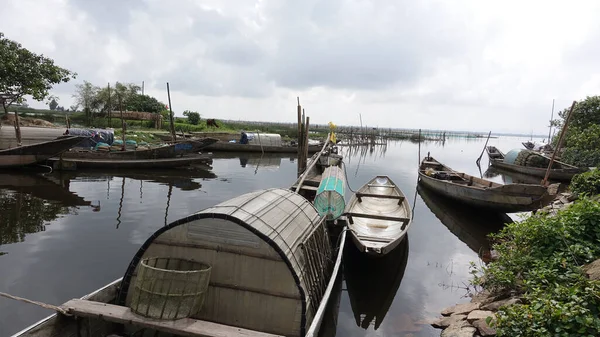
(0, 136, 85, 168)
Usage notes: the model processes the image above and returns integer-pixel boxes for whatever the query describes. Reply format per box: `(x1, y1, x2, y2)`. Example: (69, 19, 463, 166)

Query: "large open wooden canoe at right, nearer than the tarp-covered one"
(419, 157, 558, 213)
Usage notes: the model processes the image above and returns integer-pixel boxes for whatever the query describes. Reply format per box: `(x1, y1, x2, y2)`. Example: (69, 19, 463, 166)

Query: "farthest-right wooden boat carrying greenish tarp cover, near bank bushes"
(486, 146, 589, 181)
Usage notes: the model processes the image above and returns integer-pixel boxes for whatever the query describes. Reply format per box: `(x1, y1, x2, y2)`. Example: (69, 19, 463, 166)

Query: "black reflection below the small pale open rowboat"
(343, 235, 409, 330)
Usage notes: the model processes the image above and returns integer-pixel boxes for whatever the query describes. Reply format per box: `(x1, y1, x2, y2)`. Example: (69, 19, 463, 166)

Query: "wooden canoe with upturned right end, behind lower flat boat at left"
(56, 138, 217, 160)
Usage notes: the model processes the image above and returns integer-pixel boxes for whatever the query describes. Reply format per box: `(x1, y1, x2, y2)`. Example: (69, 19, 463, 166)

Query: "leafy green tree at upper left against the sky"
(0, 33, 77, 114)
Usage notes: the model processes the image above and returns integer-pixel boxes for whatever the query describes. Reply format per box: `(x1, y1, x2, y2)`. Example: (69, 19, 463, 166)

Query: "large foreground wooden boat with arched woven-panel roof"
(13, 189, 345, 337)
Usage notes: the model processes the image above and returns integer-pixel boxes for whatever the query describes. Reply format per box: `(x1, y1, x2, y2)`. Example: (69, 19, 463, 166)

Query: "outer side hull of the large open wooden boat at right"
(419, 172, 549, 213)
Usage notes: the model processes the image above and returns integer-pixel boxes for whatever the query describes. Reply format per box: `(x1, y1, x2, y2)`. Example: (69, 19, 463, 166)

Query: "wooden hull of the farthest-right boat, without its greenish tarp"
(486, 146, 588, 181)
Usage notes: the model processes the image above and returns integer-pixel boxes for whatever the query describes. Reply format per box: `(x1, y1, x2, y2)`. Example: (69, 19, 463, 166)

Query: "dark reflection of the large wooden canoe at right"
(417, 186, 513, 261)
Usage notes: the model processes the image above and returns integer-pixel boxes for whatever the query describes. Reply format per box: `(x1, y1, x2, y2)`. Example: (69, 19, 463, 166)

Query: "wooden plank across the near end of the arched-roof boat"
(62, 299, 284, 337)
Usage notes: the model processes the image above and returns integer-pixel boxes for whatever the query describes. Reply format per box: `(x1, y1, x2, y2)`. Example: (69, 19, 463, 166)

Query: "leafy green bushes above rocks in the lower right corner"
(473, 197, 600, 337)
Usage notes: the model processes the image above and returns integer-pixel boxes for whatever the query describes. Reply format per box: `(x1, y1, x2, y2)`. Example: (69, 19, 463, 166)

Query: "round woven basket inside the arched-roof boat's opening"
(130, 257, 211, 320)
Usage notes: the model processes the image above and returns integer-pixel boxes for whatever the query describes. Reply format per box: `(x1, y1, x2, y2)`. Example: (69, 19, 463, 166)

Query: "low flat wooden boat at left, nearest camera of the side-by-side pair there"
(48, 154, 212, 170)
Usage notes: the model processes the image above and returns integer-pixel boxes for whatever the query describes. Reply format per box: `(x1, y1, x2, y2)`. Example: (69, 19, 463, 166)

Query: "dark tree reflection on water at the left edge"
(0, 172, 99, 245)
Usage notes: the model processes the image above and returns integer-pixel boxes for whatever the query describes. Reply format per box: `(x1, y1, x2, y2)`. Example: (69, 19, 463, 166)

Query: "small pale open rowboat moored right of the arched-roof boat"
(345, 176, 412, 256)
